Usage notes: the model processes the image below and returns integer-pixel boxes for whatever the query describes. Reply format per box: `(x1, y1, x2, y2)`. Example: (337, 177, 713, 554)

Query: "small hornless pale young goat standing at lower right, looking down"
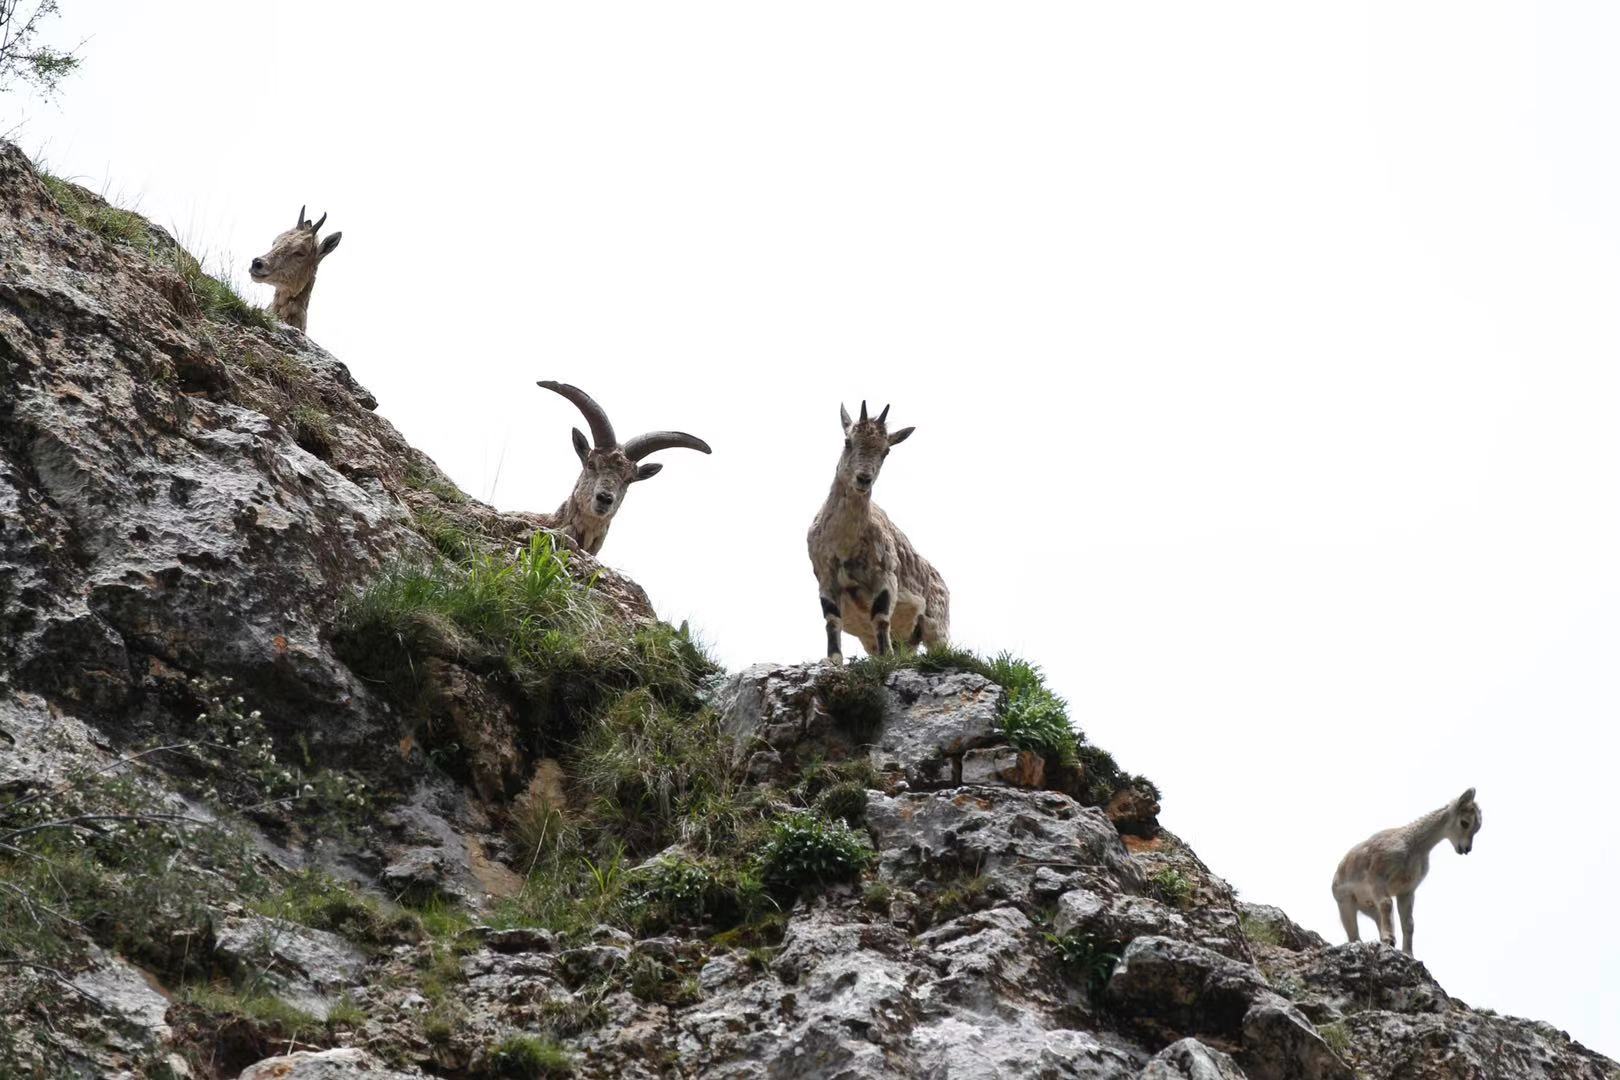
(1333, 789, 1484, 955)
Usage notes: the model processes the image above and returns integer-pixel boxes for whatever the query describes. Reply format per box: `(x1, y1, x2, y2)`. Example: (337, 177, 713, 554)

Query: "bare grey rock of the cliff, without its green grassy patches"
(0, 144, 1617, 1080)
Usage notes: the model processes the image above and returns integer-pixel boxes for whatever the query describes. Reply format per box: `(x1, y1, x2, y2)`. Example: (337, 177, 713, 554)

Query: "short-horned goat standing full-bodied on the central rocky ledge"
(808, 402, 951, 664)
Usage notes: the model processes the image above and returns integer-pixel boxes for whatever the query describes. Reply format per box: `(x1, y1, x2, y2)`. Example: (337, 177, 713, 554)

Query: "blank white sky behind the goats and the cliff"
(0, 0, 1620, 1056)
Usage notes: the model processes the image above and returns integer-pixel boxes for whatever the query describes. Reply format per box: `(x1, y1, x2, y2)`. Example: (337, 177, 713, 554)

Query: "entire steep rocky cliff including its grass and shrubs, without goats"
(0, 144, 1620, 1080)
